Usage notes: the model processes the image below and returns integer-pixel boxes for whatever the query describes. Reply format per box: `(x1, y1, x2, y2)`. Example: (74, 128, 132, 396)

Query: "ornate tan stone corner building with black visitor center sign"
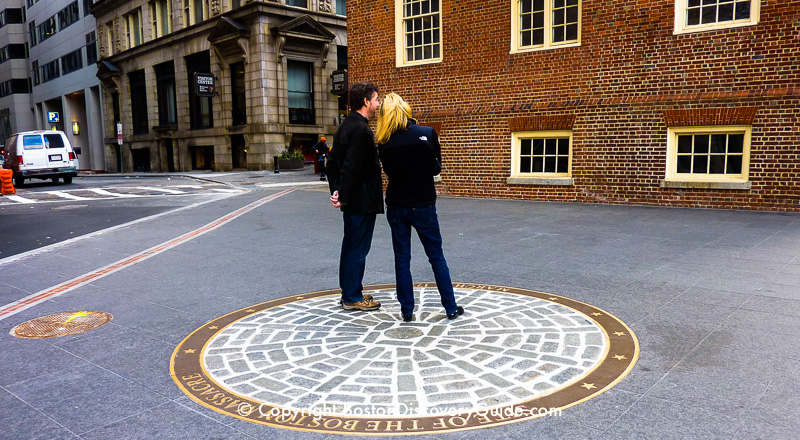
(92, 0, 347, 171)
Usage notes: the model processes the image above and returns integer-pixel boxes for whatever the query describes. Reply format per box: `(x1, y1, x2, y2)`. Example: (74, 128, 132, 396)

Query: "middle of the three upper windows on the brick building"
(511, 0, 582, 53)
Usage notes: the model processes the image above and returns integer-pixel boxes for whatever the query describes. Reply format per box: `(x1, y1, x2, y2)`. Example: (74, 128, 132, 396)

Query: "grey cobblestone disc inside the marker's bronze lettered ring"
(200, 287, 608, 416)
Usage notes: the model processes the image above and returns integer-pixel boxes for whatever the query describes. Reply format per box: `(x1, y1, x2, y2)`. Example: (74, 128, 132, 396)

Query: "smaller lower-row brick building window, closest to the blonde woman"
(511, 130, 572, 178)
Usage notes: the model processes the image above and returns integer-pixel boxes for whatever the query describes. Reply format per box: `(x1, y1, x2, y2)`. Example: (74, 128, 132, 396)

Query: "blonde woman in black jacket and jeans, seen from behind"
(376, 93, 464, 322)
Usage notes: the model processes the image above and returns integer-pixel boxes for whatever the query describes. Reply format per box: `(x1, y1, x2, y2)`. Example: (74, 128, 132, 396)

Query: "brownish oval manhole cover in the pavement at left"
(11, 311, 113, 339)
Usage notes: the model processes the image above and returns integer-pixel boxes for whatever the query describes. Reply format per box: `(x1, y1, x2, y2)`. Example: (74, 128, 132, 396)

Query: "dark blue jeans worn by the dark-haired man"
(339, 212, 375, 304)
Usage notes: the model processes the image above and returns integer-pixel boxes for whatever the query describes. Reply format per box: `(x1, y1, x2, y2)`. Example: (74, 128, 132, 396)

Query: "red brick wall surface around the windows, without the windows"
(348, 0, 800, 211)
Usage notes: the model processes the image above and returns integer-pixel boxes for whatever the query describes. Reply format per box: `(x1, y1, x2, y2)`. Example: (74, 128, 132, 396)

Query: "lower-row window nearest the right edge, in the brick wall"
(665, 125, 752, 183)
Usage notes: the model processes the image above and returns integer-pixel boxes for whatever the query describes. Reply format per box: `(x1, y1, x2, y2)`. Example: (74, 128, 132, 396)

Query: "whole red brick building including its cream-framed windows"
(348, 0, 800, 211)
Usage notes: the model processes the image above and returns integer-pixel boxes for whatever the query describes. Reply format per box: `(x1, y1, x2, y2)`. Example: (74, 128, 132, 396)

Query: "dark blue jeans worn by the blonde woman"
(386, 205, 458, 316)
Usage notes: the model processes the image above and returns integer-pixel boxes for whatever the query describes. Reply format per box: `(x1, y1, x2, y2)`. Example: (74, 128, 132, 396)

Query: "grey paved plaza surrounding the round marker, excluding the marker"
(0, 180, 800, 440)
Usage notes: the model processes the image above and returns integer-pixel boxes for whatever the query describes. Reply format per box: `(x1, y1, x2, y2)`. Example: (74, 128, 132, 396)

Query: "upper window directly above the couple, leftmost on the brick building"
(395, 0, 442, 67)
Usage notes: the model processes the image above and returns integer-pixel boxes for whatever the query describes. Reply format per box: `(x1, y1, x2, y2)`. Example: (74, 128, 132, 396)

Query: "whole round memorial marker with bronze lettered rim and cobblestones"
(171, 283, 639, 435)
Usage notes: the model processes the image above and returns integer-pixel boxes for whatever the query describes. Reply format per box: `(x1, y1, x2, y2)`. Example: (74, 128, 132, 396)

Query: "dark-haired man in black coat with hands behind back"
(327, 82, 383, 310)
